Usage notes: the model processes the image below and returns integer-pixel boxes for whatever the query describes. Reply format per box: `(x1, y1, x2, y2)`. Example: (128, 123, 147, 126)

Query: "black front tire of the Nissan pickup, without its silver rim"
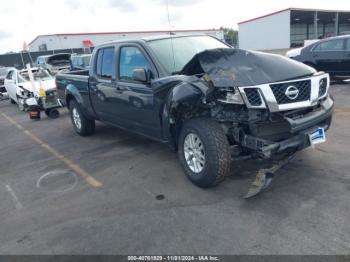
(178, 118, 231, 188)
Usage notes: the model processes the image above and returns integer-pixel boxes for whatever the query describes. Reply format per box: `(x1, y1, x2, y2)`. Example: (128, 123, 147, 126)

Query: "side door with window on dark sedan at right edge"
(312, 38, 345, 74)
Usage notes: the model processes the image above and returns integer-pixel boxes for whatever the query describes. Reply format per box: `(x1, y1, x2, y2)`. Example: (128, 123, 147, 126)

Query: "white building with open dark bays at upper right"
(238, 8, 350, 50)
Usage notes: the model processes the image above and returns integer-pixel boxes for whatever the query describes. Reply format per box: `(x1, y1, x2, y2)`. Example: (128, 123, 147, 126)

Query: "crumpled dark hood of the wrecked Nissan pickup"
(180, 48, 316, 87)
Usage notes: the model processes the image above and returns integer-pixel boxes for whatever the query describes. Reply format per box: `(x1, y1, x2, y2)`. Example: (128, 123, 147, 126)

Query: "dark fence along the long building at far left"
(0, 48, 92, 69)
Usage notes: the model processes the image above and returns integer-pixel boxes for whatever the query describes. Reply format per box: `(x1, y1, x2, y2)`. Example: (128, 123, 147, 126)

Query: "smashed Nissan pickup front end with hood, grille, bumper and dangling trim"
(176, 49, 334, 197)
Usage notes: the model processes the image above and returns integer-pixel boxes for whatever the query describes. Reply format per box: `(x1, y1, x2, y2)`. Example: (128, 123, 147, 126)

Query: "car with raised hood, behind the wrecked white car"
(35, 53, 71, 75)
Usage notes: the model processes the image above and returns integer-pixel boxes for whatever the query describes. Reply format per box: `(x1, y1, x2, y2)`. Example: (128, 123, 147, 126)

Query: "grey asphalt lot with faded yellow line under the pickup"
(0, 83, 350, 254)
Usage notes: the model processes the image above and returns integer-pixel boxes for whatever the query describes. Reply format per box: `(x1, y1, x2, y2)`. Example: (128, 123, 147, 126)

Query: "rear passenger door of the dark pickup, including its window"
(89, 46, 119, 124)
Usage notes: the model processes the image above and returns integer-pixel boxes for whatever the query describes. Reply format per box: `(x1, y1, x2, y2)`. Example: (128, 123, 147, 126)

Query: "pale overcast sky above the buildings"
(0, 0, 350, 53)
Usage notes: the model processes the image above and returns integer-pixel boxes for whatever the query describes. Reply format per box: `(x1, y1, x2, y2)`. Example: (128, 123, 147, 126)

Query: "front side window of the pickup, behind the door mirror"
(119, 46, 150, 80)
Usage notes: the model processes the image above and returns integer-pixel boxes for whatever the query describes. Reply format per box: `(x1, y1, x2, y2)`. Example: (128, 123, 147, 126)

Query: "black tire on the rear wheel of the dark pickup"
(69, 100, 95, 136)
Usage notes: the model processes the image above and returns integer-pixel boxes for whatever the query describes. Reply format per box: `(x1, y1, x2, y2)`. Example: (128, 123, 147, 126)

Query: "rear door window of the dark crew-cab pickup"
(96, 47, 115, 79)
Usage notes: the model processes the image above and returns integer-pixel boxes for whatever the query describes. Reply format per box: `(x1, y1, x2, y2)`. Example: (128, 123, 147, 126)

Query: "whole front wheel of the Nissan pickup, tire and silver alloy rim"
(178, 118, 231, 188)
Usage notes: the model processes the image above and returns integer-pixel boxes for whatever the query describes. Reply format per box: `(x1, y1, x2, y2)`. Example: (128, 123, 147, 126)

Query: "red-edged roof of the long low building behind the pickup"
(28, 29, 222, 45)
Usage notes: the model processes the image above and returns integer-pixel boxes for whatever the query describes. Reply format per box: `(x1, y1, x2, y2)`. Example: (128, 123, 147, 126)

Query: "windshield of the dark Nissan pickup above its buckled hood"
(148, 36, 229, 73)
